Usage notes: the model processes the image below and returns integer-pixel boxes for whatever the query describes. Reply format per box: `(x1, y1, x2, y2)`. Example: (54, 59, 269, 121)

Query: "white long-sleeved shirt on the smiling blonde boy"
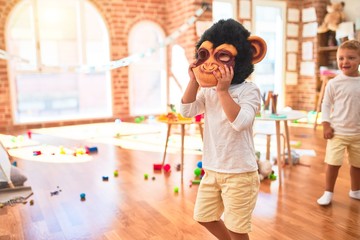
(321, 73, 360, 135)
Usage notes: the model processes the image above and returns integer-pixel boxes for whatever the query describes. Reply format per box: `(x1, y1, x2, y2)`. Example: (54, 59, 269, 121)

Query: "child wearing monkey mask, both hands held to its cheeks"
(180, 19, 266, 239)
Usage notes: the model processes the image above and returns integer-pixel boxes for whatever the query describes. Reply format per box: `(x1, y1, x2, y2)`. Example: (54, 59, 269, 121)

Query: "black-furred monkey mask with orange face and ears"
(192, 19, 266, 87)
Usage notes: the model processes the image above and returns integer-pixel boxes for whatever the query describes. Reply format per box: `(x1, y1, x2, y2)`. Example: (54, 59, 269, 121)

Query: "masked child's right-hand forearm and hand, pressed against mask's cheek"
(214, 65, 241, 122)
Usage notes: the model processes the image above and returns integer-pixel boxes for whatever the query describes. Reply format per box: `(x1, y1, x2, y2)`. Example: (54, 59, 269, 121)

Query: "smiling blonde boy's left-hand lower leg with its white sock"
(317, 164, 340, 205)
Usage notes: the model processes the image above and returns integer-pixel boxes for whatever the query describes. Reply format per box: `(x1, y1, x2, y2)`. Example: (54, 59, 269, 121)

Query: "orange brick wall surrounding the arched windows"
(0, 0, 328, 132)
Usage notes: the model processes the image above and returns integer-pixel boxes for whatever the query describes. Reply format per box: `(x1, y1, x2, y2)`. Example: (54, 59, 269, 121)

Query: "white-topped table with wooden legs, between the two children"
(255, 110, 307, 184)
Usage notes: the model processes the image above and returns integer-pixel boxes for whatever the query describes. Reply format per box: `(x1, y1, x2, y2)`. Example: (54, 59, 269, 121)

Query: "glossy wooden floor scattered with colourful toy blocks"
(0, 123, 360, 240)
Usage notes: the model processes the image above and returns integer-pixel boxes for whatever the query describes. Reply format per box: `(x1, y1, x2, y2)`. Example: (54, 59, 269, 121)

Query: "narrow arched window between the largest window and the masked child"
(128, 21, 167, 116)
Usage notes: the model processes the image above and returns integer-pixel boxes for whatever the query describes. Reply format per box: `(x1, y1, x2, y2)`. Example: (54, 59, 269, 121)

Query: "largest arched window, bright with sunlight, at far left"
(6, 0, 112, 123)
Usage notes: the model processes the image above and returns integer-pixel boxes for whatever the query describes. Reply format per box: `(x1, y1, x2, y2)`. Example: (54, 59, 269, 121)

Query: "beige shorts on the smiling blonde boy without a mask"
(325, 135, 360, 168)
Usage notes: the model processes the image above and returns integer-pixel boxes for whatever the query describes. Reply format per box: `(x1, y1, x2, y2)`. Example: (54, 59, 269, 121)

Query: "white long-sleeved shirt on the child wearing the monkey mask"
(180, 82, 261, 173)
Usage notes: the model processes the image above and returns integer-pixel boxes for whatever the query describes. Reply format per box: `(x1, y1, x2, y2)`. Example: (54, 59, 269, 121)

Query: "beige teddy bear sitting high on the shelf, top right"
(318, 2, 345, 33)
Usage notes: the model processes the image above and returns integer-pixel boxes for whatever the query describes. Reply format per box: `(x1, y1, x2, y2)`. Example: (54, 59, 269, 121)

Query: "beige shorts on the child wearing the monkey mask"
(194, 170, 260, 233)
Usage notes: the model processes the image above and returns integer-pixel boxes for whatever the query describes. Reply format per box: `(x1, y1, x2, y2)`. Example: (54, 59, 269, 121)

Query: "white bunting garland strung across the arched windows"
(0, 3, 210, 73)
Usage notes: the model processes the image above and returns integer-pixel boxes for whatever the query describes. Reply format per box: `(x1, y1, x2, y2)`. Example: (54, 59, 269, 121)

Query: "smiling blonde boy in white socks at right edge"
(317, 40, 360, 205)
